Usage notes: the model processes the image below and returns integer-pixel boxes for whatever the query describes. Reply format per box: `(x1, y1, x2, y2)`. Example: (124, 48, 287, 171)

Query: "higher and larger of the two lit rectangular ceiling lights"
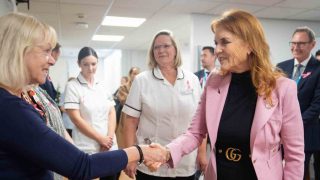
(102, 16, 146, 27)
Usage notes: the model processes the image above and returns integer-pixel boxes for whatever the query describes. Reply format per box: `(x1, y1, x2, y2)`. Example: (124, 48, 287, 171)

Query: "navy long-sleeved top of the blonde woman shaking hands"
(0, 88, 128, 180)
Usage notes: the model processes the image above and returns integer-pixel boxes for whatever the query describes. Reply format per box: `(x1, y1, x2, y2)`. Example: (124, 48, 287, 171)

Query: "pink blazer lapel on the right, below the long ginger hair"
(250, 92, 278, 151)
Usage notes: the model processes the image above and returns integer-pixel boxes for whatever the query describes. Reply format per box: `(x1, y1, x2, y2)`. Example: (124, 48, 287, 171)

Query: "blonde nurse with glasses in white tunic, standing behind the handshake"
(122, 31, 205, 180)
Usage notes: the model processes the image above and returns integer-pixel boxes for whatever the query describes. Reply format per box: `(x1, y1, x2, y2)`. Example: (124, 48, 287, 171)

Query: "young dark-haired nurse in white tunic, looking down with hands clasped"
(64, 47, 118, 180)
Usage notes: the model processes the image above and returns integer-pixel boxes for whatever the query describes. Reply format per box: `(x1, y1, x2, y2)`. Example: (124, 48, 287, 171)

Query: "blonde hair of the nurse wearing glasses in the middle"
(147, 30, 182, 69)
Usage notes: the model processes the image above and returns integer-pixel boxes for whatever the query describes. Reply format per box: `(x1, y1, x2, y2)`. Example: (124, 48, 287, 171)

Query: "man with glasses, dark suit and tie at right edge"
(277, 27, 320, 179)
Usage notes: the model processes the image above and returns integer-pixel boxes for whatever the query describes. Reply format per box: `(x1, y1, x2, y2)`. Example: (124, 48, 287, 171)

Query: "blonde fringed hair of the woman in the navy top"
(0, 13, 57, 92)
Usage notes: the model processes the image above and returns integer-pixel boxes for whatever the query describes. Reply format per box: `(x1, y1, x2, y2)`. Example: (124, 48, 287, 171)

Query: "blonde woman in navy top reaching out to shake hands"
(0, 13, 164, 180)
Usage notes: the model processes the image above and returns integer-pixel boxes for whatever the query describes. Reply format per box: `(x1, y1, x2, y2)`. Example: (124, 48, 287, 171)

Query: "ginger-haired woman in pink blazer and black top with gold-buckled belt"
(149, 10, 304, 180)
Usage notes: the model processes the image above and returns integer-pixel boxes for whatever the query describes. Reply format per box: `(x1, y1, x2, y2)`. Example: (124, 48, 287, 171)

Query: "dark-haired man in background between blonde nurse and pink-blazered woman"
(194, 46, 216, 88)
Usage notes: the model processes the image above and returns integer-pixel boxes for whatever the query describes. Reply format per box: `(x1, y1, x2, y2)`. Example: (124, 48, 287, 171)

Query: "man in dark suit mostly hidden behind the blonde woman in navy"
(40, 43, 61, 100)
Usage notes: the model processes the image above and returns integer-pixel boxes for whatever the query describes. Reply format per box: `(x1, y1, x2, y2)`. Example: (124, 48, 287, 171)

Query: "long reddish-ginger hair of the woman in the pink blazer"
(211, 10, 283, 106)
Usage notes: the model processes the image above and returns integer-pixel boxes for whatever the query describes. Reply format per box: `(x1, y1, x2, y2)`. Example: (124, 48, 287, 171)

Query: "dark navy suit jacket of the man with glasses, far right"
(277, 56, 320, 151)
